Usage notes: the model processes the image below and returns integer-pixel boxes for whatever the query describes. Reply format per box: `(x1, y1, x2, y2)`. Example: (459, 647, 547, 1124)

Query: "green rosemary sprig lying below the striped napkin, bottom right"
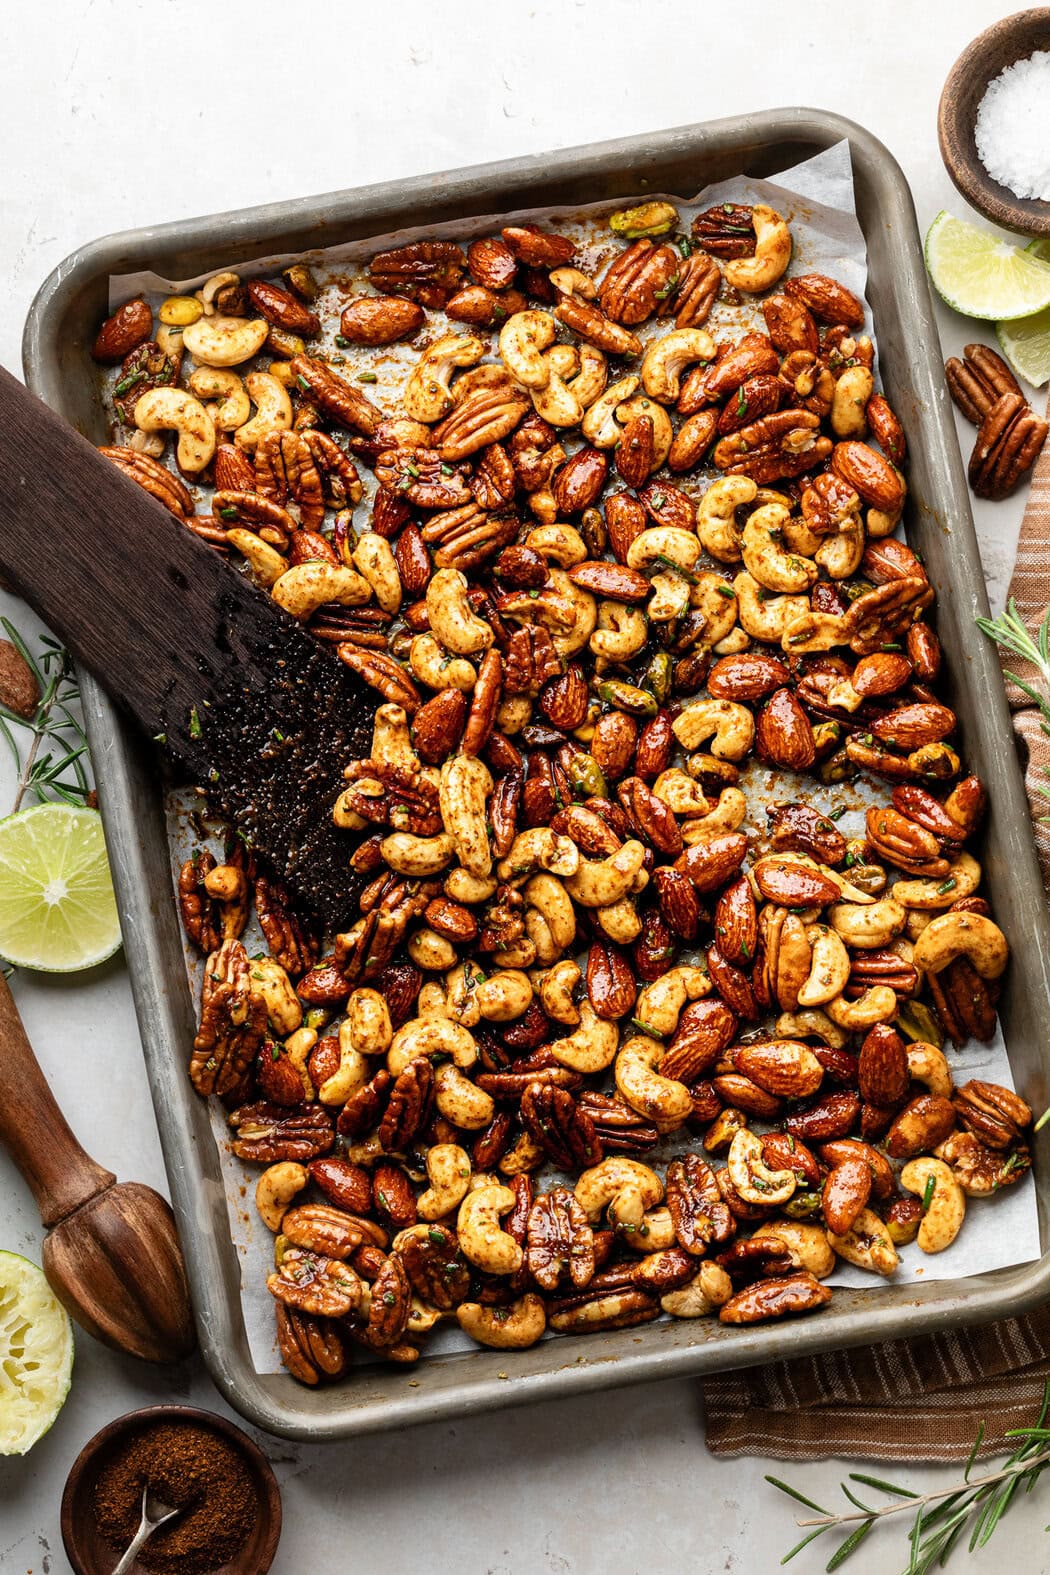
(765, 1383, 1050, 1575)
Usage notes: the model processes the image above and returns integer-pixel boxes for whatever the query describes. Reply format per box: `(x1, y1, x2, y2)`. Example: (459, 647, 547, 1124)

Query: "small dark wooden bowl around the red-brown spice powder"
(61, 1405, 280, 1575)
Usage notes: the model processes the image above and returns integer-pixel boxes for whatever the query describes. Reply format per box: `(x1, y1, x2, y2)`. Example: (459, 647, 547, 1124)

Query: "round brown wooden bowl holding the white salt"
(937, 6, 1050, 235)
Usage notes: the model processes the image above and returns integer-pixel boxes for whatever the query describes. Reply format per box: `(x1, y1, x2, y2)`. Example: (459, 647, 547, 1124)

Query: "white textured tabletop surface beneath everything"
(0, 0, 1050, 1575)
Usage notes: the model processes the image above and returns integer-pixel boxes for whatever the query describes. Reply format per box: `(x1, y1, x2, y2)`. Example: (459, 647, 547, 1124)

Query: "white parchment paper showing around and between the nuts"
(109, 142, 1041, 1373)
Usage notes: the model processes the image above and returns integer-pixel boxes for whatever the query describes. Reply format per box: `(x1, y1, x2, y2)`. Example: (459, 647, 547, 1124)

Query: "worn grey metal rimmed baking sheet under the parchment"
(24, 109, 1050, 1440)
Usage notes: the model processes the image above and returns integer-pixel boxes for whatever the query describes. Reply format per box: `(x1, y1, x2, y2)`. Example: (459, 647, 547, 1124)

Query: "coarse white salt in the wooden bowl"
(974, 49, 1050, 202)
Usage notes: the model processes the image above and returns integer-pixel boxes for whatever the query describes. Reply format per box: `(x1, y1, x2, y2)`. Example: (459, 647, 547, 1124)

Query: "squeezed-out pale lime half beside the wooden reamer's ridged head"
(0, 1252, 72, 1455)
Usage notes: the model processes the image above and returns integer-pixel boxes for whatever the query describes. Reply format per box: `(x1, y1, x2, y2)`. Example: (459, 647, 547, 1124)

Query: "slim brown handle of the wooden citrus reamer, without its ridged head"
(0, 975, 116, 1227)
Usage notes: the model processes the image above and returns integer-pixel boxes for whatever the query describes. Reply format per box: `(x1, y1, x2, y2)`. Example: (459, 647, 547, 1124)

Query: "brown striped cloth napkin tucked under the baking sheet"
(704, 393, 1050, 1462)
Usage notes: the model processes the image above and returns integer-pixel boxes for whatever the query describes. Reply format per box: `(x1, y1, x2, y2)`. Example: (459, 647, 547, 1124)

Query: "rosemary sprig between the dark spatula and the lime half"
(0, 617, 91, 813)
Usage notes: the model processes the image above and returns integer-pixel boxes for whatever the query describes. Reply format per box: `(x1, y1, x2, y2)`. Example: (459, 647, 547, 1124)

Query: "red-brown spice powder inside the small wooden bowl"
(94, 1422, 257, 1575)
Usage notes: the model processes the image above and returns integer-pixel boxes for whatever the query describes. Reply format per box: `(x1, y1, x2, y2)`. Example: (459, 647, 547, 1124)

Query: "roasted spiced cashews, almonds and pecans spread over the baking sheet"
(96, 193, 1031, 1384)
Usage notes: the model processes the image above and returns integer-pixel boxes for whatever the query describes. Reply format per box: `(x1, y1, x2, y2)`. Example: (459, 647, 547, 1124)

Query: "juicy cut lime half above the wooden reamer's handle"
(0, 803, 120, 973)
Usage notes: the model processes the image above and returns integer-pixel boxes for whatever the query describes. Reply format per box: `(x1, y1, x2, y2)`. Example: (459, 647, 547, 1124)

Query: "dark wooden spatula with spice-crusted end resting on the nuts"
(0, 367, 379, 929)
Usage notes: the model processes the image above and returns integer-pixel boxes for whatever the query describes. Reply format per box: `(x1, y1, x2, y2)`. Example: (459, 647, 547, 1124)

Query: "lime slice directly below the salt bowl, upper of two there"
(926, 209, 1050, 321)
